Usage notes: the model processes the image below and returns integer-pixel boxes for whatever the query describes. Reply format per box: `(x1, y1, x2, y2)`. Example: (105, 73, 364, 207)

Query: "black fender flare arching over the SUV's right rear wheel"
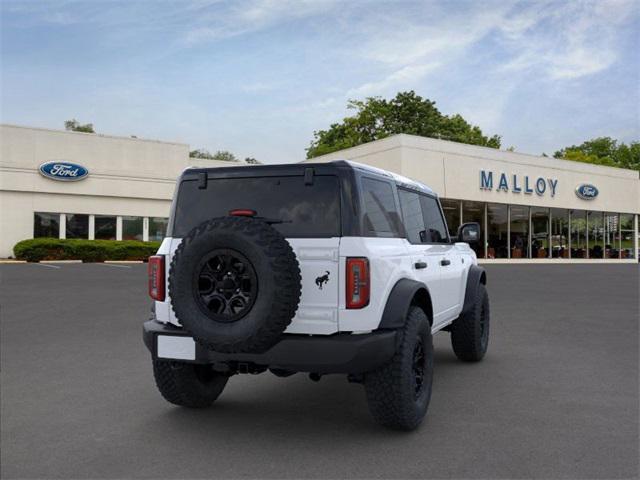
(378, 278, 433, 329)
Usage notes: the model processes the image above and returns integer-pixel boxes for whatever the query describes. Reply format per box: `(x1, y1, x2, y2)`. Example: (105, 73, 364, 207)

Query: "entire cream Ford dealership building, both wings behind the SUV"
(0, 125, 640, 263)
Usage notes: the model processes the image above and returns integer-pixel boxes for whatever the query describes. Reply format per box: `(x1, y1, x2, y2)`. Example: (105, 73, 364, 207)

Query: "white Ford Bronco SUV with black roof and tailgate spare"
(143, 161, 489, 430)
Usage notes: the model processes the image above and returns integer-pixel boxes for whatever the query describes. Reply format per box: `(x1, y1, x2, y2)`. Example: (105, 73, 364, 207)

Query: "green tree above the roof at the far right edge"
(553, 137, 640, 171)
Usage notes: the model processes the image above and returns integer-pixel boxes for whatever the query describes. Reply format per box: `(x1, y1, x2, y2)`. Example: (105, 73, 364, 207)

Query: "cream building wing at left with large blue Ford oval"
(0, 125, 239, 258)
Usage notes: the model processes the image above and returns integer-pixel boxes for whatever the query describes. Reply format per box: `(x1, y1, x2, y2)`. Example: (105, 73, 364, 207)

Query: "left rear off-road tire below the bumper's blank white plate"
(153, 360, 229, 408)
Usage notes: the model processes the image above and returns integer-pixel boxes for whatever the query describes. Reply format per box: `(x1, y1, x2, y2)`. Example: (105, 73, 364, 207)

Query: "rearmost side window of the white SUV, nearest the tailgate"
(362, 177, 399, 236)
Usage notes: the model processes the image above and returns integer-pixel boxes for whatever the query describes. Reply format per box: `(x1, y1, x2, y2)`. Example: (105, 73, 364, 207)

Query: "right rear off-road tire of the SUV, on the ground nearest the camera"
(364, 307, 433, 430)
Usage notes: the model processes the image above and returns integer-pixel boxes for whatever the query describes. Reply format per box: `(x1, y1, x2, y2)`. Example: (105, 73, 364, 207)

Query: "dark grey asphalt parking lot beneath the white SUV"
(0, 264, 639, 478)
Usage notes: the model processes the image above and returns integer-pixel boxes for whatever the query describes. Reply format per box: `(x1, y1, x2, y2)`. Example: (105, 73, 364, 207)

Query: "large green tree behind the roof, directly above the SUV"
(307, 90, 500, 158)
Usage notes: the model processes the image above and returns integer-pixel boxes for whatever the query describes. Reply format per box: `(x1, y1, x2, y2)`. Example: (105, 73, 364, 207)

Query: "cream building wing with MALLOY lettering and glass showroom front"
(307, 135, 640, 263)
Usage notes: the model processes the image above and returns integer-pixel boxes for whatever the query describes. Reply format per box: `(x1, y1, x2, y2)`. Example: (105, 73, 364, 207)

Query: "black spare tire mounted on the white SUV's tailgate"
(169, 217, 301, 352)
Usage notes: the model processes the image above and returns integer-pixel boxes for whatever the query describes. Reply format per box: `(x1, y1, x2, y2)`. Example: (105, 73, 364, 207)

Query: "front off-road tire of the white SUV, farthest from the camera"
(451, 284, 490, 362)
